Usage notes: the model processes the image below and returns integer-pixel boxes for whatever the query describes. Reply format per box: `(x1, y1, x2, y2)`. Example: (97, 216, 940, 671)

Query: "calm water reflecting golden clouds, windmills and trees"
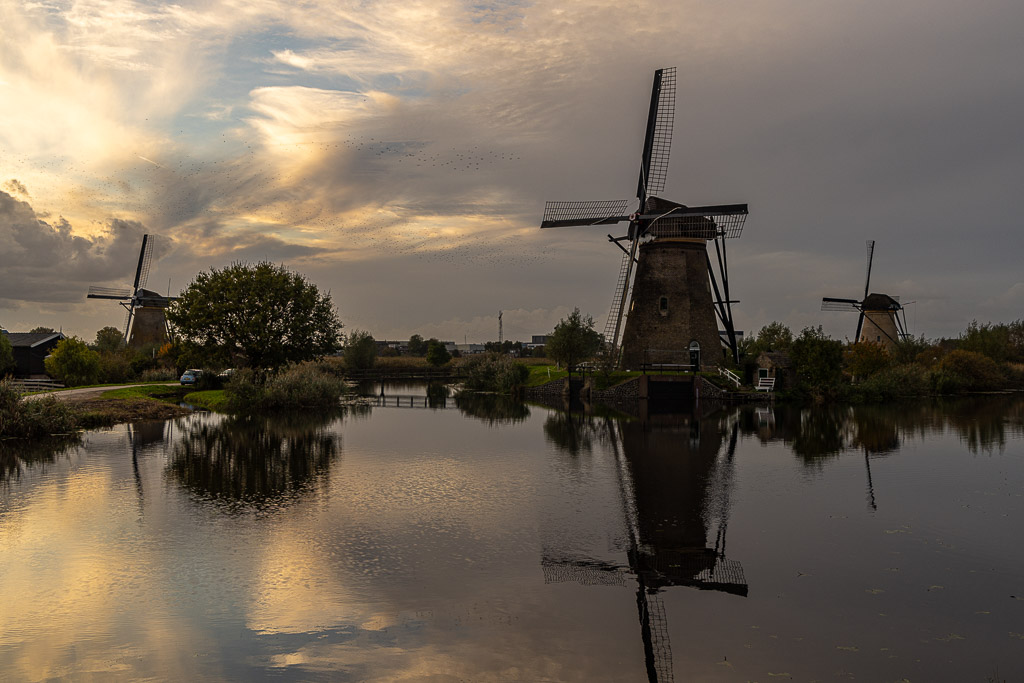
(0, 391, 1024, 681)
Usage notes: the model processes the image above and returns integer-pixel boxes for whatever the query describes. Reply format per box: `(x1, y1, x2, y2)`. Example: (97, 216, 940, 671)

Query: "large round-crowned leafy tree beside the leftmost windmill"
(167, 261, 341, 371)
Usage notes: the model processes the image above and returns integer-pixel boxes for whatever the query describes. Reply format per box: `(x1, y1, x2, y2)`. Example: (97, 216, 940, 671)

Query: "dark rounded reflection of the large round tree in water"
(168, 414, 341, 509)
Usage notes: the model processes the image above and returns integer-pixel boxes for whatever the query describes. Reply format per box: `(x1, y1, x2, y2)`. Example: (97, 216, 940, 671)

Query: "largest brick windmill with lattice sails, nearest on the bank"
(541, 67, 748, 368)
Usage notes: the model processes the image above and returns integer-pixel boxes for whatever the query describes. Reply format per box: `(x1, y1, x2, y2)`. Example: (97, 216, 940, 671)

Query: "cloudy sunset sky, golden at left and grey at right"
(0, 0, 1024, 343)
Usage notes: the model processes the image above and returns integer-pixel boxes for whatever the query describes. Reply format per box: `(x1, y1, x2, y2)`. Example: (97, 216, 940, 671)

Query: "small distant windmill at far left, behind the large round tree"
(86, 234, 176, 347)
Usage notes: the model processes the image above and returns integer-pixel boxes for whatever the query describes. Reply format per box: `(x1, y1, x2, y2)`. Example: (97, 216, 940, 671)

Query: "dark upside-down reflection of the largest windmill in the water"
(542, 414, 748, 682)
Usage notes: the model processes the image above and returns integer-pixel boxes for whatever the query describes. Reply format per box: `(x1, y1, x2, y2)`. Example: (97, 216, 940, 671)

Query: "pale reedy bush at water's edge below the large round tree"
(225, 365, 345, 413)
